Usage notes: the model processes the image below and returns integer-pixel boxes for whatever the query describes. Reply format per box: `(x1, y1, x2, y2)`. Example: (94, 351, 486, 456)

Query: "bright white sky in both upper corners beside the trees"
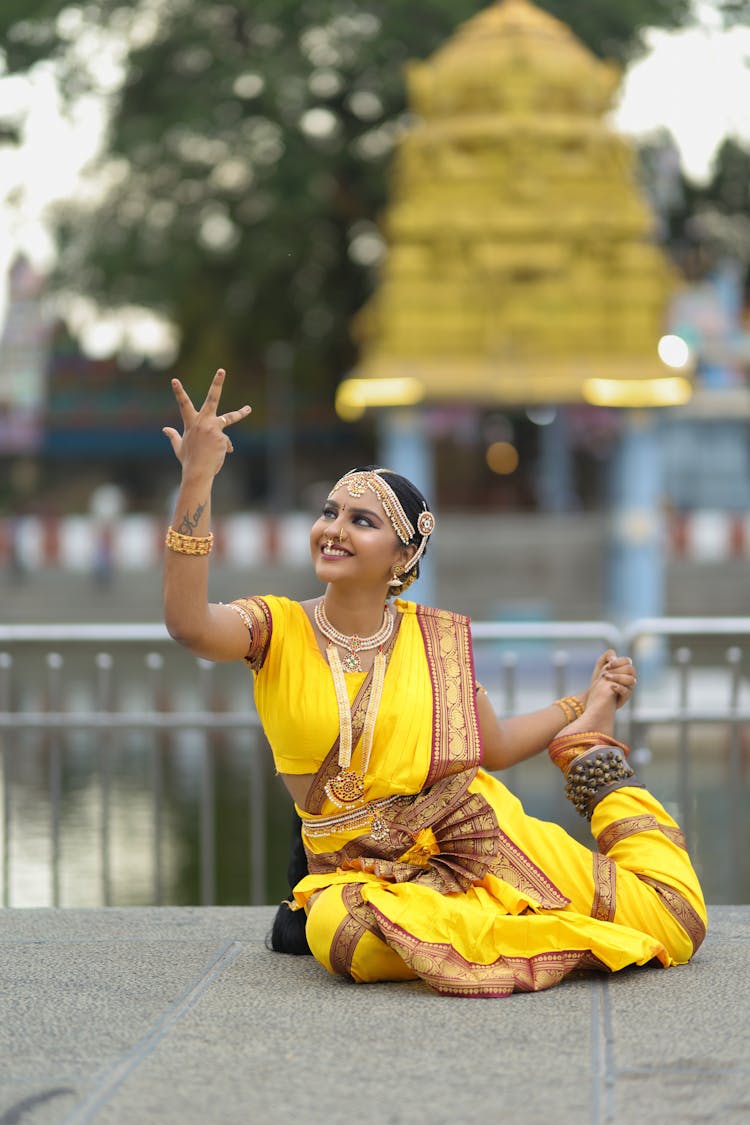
(0, 2, 750, 337)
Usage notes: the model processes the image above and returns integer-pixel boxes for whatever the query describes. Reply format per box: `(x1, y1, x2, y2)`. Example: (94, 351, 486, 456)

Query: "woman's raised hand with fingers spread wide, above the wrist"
(162, 368, 252, 477)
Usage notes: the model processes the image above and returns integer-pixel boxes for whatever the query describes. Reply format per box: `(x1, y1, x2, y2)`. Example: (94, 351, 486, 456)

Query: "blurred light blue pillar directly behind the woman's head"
(378, 406, 440, 605)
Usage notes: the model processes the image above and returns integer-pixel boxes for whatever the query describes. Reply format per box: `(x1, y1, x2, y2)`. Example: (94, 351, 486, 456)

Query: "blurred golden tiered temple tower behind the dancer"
(337, 0, 689, 417)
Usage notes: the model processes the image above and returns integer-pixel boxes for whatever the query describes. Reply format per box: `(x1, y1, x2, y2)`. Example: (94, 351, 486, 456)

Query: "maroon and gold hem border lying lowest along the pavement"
(371, 907, 609, 999)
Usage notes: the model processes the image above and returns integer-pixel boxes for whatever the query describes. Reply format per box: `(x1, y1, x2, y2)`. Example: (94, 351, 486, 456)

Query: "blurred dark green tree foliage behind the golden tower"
(0, 0, 715, 416)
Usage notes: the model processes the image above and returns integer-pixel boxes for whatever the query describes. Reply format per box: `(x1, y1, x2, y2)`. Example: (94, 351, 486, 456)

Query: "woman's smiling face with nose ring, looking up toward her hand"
(310, 487, 412, 586)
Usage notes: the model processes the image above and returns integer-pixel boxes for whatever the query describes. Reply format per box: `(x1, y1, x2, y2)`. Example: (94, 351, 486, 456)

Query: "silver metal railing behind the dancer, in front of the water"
(0, 618, 750, 906)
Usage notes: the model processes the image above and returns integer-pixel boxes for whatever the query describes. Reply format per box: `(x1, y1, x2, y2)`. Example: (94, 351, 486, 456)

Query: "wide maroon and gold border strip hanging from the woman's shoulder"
(415, 605, 481, 786)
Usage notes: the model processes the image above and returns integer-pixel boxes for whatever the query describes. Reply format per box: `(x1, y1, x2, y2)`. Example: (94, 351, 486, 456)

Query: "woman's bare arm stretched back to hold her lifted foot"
(477, 649, 636, 771)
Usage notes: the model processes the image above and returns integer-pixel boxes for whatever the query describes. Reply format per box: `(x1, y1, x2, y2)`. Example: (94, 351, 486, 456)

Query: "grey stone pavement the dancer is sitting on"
(0, 906, 750, 1125)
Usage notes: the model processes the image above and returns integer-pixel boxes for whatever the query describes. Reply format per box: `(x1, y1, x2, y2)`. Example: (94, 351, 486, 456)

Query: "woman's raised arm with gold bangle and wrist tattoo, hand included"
(164, 369, 251, 660)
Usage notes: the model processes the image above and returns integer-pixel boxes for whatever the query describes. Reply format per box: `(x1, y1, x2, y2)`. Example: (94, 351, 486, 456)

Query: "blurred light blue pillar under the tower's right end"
(607, 410, 665, 643)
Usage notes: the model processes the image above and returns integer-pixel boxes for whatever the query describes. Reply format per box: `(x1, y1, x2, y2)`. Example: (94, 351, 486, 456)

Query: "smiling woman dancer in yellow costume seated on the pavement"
(164, 370, 706, 997)
